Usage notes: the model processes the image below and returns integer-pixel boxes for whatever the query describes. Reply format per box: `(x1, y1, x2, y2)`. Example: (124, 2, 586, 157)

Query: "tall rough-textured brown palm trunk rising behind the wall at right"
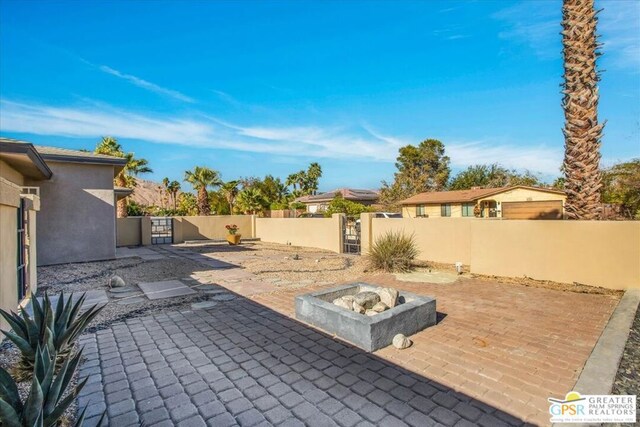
(562, 0, 604, 219)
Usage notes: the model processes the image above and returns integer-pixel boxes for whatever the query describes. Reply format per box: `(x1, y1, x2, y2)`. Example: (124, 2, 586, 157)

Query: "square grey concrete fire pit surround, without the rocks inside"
(296, 283, 436, 351)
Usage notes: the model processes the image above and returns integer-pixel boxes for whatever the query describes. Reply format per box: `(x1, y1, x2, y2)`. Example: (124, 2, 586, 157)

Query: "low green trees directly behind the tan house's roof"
(449, 163, 544, 190)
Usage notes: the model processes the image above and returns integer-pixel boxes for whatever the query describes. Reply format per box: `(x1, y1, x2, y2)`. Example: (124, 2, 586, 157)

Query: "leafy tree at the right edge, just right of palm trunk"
(602, 159, 640, 219)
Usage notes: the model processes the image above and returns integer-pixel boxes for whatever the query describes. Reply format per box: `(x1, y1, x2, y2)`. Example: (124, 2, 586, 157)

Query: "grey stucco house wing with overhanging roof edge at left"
(0, 138, 130, 265)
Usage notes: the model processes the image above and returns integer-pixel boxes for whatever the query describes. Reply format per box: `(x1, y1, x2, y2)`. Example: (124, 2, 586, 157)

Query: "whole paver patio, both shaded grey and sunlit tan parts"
(79, 249, 618, 426)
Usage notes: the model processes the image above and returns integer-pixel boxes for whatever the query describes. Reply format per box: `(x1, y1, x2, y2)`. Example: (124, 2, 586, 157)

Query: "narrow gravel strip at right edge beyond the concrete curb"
(611, 302, 640, 425)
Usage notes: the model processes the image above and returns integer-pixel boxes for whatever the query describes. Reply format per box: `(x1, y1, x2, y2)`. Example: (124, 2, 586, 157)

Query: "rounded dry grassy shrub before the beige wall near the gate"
(369, 231, 418, 272)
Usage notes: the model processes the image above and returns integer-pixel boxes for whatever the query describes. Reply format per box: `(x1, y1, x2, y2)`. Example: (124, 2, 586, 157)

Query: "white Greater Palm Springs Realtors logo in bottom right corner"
(548, 391, 637, 423)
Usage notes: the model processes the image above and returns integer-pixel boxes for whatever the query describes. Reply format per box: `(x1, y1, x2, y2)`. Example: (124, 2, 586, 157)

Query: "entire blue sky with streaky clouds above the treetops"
(0, 0, 640, 190)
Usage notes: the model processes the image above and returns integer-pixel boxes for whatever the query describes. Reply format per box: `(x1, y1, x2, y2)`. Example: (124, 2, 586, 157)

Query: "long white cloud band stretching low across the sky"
(0, 100, 562, 174)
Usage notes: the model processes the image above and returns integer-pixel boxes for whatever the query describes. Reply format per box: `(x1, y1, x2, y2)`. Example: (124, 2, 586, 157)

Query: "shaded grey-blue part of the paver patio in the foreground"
(78, 298, 540, 427)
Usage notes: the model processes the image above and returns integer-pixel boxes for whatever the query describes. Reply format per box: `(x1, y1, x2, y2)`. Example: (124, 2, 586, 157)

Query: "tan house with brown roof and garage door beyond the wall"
(400, 185, 566, 219)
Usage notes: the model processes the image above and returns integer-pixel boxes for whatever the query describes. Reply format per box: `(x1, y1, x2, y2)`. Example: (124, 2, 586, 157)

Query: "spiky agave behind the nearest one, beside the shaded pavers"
(0, 293, 104, 379)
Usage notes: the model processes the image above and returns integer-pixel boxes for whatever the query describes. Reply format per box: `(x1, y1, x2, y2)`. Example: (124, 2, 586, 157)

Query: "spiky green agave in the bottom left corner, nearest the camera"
(0, 347, 105, 427)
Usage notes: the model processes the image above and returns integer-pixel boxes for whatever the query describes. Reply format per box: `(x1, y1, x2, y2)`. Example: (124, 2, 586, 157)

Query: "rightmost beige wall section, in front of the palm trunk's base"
(471, 220, 640, 289)
